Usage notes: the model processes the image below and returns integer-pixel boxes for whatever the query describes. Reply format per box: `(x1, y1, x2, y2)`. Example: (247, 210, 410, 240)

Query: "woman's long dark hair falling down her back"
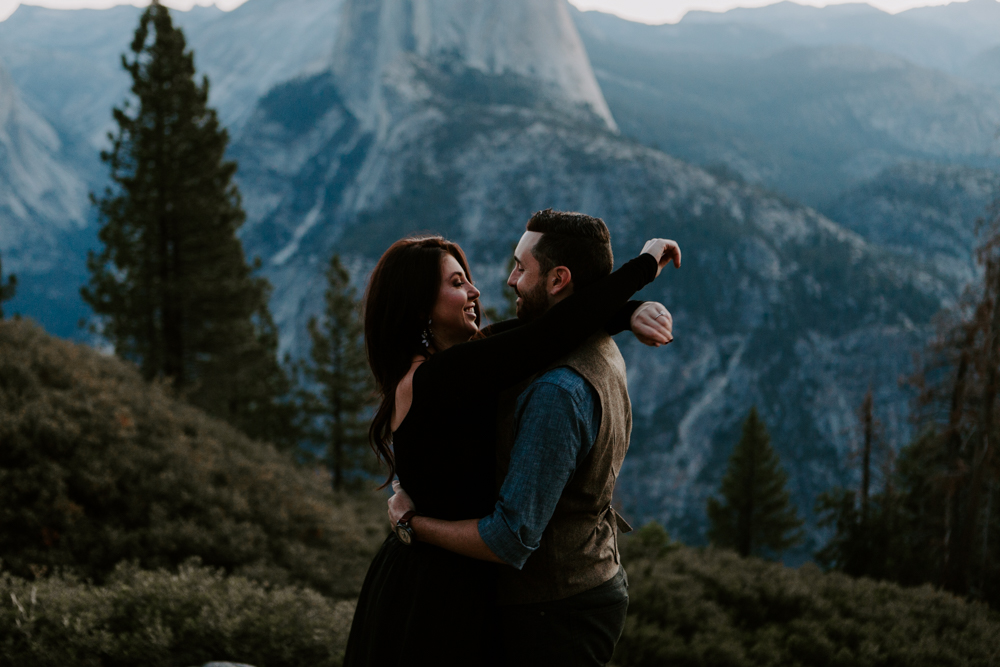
(365, 236, 480, 488)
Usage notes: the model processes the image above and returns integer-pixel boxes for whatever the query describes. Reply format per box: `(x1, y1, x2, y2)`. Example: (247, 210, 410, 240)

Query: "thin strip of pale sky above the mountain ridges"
(0, 0, 972, 23)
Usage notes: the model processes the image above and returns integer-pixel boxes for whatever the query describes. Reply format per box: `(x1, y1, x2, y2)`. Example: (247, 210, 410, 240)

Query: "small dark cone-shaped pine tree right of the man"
(708, 408, 802, 557)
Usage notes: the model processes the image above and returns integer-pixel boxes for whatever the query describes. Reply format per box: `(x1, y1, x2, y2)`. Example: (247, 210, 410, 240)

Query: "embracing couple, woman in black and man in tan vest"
(344, 210, 681, 667)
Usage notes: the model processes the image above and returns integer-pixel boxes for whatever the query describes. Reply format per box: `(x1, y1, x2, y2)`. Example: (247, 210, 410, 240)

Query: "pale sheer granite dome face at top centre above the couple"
(333, 0, 614, 133)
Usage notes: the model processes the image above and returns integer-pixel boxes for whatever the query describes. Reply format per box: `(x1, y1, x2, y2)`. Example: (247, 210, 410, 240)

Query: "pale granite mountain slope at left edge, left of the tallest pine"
(0, 64, 91, 329)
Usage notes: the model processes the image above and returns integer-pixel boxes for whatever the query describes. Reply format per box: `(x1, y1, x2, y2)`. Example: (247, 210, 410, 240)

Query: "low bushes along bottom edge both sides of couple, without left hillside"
(0, 525, 1000, 667)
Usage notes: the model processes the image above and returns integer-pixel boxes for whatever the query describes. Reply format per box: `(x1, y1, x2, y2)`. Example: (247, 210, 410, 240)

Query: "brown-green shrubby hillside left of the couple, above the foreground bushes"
(0, 322, 387, 598)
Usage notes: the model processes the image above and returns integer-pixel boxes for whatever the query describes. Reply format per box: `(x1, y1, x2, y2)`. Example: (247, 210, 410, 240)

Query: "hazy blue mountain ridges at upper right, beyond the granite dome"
(574, 0, 1000, 206)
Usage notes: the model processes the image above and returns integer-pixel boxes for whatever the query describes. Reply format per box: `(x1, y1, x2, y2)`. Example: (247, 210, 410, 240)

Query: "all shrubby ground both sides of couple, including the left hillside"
(0, 321, 1000, 667)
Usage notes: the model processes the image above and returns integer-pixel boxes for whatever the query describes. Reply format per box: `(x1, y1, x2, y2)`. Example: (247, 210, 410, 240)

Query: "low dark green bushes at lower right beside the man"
(615, 528, 1000, 667)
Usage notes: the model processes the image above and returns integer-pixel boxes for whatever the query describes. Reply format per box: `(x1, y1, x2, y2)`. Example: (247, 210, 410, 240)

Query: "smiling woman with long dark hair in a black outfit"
(344, 232, 666, 666)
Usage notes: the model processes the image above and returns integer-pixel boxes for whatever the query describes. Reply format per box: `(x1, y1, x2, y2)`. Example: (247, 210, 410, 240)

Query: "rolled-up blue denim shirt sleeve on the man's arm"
(479, 368, 601, 570)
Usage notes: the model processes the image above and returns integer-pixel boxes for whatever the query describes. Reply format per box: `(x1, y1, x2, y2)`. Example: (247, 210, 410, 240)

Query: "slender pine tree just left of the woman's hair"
(302, 255, 375, 491)
